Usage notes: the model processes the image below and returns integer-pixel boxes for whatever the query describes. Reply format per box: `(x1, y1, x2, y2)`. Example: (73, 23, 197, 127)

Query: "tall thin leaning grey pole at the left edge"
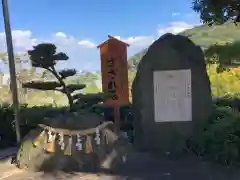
(2, 0, 21, 144)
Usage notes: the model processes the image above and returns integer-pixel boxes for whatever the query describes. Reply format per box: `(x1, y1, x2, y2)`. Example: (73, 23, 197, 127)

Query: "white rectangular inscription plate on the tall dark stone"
(153, 69, 192, 122)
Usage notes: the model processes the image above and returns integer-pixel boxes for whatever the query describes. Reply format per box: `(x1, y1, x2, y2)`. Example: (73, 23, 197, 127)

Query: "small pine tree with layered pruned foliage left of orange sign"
(22, 43, 109, 112)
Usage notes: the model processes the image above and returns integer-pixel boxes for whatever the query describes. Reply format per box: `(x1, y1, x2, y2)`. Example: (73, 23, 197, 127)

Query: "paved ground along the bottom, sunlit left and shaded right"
(0, 153, 240, 180)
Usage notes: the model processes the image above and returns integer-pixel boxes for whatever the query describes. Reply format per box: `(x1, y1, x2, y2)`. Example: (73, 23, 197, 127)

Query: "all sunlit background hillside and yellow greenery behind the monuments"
(7, 23, 240, 106)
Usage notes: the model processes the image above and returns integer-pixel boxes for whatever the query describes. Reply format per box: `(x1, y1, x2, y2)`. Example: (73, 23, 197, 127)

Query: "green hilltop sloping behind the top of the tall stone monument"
(128, 23, 240, 70)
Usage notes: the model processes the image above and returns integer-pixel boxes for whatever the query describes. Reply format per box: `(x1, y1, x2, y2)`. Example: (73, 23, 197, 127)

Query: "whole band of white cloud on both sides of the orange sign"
(0, 21, 195, 71)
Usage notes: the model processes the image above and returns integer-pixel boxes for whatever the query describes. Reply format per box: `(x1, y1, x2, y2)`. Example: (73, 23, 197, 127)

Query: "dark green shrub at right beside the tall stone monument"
(190, 105, 240, 165)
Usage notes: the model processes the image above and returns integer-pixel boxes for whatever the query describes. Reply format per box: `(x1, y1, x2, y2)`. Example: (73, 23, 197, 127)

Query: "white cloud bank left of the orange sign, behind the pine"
(0, 30, 99, 70)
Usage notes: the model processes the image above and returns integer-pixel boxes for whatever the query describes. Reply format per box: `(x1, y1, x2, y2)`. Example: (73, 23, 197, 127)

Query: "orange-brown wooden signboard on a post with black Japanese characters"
(98, 36, 129, 134)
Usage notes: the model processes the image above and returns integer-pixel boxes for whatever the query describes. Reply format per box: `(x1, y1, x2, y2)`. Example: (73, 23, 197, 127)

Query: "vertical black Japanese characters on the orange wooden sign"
(107, 57, 118, 100)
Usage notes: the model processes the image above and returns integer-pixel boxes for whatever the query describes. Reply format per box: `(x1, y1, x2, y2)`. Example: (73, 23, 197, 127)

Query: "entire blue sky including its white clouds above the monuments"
(0, 0, 200, 71)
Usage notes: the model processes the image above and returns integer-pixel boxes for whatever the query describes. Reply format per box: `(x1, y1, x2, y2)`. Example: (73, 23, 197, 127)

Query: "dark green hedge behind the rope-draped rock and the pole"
(0, 104, 131, 148)
